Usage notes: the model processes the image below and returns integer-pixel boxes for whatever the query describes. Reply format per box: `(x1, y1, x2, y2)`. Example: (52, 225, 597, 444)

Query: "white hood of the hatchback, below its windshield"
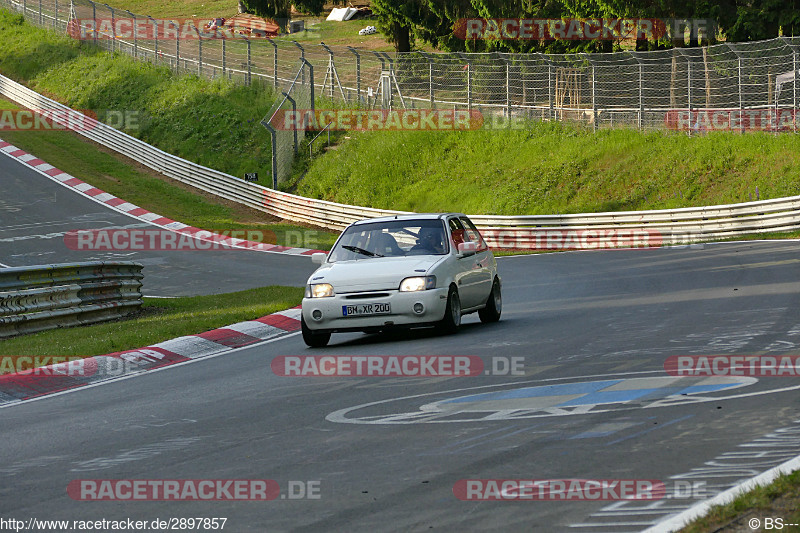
(308, 255, 447, 293)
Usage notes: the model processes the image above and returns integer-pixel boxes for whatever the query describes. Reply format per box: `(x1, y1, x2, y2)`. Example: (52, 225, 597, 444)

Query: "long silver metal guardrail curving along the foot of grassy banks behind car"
(0, 75, 800, 249)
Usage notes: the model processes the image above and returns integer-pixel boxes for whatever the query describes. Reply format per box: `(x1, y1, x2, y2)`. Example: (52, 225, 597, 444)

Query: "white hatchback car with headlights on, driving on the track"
(301, 213, 502, 347)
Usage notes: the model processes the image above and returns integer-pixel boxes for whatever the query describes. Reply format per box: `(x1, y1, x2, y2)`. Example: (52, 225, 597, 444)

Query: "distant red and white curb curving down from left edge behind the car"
(0, 139, 324, 255)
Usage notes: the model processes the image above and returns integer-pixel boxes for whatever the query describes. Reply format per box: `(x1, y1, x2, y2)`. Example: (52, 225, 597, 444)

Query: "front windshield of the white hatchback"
(328, 219, 450, 263)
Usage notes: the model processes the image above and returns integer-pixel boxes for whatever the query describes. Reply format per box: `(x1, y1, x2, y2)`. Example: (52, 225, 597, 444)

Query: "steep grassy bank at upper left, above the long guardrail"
(0, 10, 274, 179)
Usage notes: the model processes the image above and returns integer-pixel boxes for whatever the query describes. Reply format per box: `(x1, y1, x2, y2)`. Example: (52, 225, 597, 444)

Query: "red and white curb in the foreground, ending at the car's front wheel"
(0, 306, 300, 408)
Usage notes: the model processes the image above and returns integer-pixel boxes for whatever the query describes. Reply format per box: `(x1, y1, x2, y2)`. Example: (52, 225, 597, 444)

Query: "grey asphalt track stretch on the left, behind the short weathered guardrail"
(0, 155, 314, 296)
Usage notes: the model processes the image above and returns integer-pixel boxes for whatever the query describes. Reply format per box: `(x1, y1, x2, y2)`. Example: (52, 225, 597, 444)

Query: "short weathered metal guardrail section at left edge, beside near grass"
(0, 261, 143, 338)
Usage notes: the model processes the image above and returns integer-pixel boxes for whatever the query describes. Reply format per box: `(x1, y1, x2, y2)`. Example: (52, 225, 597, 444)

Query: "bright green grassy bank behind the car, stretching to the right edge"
(298, 123, 800, 215)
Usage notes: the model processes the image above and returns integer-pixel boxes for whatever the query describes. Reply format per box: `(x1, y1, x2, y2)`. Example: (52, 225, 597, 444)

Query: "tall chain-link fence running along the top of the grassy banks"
(0, 0, 800, 179)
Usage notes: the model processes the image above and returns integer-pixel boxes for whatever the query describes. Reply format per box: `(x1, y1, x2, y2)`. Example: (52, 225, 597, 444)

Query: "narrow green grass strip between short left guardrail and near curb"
(0, 286, 303, 357)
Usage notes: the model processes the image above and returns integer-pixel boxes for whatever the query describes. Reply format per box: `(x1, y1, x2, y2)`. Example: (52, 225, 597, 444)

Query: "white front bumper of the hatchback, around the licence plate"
(302, 287, 448, 331)
